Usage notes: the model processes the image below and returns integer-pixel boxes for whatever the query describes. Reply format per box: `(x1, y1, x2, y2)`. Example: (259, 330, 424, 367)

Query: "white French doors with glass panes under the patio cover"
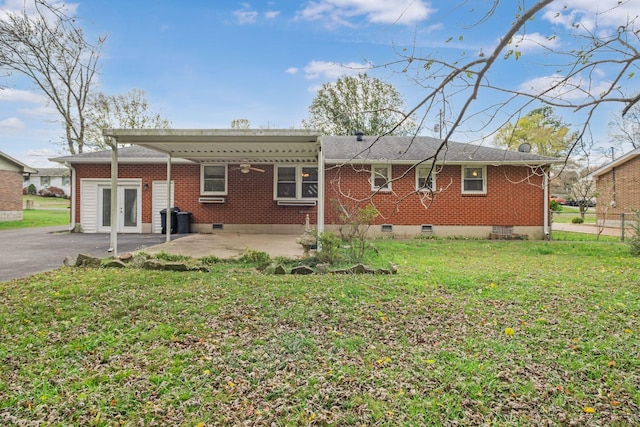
(98, 185, 142, 233)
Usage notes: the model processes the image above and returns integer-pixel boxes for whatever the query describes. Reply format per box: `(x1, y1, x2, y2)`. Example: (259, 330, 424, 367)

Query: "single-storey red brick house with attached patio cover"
(52, 129, 557, 239)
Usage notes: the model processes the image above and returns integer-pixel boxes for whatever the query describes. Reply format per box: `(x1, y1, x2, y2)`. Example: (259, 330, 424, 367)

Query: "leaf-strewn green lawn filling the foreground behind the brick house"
(0, 240, 640, 426)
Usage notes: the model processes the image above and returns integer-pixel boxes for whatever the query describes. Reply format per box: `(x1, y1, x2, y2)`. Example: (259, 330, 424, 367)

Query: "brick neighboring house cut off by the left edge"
(0, 151, 37, 222)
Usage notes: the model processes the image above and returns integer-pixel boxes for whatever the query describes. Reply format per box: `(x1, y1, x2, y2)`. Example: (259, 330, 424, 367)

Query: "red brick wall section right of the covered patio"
(325, 165, 544, 226)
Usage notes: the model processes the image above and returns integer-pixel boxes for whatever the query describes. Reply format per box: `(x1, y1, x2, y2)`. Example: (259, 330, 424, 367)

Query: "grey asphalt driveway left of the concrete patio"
(0, 227, 172, 282)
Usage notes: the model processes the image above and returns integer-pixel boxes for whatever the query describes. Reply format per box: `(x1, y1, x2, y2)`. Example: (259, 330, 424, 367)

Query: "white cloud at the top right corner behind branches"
(543, 0, 640, 31)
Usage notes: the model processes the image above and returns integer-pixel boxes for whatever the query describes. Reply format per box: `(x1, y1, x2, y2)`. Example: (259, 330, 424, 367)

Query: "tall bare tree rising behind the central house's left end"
(0, 0, 105, 154)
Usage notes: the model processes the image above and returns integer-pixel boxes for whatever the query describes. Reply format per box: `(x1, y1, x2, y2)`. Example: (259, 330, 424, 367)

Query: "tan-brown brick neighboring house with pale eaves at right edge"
(590, 148, 640, 214)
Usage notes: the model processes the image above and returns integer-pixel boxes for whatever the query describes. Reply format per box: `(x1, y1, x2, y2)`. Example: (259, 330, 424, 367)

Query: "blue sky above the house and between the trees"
(0, 0, 640, 167)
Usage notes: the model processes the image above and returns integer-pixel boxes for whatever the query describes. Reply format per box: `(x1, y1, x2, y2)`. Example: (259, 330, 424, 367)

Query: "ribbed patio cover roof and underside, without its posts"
(103, 129, 320, 163)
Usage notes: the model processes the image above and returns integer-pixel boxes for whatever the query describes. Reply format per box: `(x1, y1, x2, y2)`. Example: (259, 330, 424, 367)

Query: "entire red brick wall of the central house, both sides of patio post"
(74, 164, 544, 226)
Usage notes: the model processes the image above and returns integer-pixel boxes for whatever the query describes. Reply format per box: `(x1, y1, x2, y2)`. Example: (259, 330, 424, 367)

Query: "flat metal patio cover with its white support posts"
(103, 129, 324, 255)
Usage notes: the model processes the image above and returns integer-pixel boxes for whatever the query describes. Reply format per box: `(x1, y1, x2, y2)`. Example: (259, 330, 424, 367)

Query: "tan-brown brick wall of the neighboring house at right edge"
(596, 156, 640, 214)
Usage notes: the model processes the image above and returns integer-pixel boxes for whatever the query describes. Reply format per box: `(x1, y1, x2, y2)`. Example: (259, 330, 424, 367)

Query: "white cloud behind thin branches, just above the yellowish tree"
(518, 74, 611, 102)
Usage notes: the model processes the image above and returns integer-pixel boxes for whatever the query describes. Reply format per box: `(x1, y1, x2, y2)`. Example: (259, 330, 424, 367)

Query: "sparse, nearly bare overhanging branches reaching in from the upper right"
(384, 0, 640, 157)
